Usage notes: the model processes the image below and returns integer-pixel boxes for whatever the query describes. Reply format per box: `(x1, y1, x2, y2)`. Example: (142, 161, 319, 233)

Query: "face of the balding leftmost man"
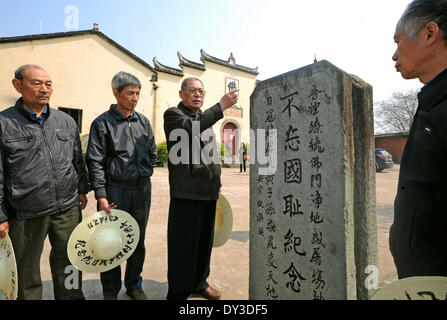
(12, 67, 53, 105)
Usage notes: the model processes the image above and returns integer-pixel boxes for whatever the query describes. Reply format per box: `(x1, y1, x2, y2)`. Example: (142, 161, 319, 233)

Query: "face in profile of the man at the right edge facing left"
(392, 30, 426, 79)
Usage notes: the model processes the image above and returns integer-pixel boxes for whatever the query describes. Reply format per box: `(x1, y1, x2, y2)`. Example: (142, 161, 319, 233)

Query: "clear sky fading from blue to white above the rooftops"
(0, 0, 421, 100)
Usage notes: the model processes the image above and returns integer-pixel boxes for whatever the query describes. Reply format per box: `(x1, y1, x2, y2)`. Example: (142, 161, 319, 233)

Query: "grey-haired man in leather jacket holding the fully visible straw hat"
(86, 72, 157, 300)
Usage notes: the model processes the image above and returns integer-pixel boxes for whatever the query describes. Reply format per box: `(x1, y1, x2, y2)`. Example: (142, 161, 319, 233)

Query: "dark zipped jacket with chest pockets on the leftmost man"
(0, 98, 89, 222)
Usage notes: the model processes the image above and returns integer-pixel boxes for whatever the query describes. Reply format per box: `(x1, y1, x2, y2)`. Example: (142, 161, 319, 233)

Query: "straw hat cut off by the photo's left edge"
(0, 234, 18, 300)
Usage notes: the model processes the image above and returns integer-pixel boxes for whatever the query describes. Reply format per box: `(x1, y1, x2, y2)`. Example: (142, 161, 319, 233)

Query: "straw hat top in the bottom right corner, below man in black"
(372, 277, 447, 300)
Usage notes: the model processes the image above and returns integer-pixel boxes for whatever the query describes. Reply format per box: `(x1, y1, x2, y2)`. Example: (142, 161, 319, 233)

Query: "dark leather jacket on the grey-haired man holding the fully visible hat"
(86, 104, 157, 199)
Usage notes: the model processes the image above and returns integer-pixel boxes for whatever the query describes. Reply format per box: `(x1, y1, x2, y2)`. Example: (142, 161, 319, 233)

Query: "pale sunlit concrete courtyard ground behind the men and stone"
(36, 166, 399, 300)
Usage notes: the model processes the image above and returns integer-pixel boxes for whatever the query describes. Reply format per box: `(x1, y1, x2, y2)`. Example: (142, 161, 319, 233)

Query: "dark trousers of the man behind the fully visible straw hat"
(100, 181, 151, 297)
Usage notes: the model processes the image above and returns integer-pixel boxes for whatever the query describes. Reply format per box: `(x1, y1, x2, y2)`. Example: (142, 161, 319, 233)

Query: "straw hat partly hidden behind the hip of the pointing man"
(213, 193, 233, 247)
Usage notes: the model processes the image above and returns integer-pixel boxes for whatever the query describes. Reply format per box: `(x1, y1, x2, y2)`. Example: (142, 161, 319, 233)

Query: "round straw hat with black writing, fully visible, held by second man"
(67, 209, 140, 273)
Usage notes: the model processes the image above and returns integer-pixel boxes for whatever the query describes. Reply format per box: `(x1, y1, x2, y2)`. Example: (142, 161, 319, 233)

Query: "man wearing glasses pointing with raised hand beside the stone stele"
(164, 78, 239, 300)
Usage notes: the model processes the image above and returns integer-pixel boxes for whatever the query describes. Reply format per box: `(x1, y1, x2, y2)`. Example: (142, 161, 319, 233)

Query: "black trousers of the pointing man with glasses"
(166, 198, 216, 300)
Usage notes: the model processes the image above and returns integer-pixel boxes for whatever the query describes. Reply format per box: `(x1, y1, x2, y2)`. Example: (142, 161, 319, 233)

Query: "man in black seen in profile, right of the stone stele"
(390, 0, 447, 278)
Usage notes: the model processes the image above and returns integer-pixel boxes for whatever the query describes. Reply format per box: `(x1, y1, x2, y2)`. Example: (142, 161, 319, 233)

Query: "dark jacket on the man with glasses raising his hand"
(163, 102, 223, 200)
